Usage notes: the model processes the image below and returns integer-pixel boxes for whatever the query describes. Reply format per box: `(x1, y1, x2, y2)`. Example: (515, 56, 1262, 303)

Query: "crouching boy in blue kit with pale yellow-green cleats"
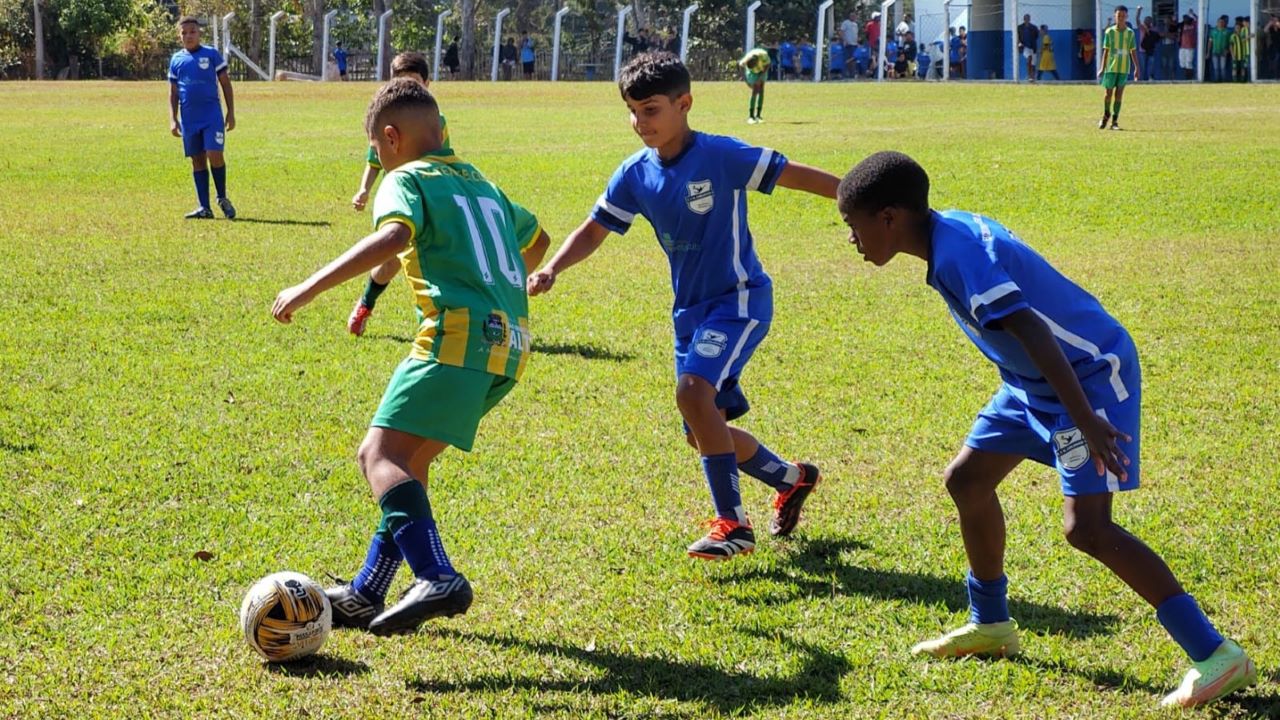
(838, 152, 1257, 707)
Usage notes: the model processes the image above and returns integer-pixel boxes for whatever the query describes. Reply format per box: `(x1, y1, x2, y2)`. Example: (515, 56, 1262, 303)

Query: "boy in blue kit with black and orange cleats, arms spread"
(529, 53, 838, 560)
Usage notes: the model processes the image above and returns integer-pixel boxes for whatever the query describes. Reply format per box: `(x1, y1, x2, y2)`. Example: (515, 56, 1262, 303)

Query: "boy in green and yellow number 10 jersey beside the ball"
(271, 78, 549, 634)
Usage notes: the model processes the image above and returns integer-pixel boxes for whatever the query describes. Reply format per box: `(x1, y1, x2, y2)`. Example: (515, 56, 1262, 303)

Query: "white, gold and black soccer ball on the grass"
(241, 571, 333, 662)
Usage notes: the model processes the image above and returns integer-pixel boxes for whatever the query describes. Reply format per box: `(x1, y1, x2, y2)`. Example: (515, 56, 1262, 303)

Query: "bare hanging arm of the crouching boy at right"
(1000, 309, 1132, 480)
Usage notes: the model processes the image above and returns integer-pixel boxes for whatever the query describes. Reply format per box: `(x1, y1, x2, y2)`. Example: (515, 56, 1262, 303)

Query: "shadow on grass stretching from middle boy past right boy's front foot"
(724, 538, 1116, 638)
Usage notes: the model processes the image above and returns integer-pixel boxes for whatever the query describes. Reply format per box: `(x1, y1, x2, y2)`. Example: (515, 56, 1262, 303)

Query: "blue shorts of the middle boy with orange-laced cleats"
(676, 314, 769, 425)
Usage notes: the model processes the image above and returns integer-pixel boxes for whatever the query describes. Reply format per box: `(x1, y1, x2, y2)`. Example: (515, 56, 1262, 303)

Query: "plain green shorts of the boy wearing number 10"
(370, 357, 516, 452)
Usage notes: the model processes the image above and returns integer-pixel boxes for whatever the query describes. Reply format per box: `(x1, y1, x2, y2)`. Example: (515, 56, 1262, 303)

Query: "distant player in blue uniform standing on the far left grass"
(169, 15, 236, 219)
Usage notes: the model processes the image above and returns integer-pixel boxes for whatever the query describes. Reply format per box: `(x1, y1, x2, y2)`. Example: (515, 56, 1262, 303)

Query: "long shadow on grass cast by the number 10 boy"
(408, 630, 851, 715)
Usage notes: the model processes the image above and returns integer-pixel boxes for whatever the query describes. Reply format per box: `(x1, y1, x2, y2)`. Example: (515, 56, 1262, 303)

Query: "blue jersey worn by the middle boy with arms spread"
(591, 132, 787, 336)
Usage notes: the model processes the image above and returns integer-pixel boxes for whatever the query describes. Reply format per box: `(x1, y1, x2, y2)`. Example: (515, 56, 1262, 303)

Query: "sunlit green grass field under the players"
(0, 83, 1280, 719)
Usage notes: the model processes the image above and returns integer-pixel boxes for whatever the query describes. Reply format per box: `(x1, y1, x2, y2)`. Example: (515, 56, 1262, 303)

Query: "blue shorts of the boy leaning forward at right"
(964, 384, 1142, 496)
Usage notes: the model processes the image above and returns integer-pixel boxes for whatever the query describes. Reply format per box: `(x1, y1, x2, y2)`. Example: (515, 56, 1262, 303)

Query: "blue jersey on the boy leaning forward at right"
(925, 210, 1142, 414)
